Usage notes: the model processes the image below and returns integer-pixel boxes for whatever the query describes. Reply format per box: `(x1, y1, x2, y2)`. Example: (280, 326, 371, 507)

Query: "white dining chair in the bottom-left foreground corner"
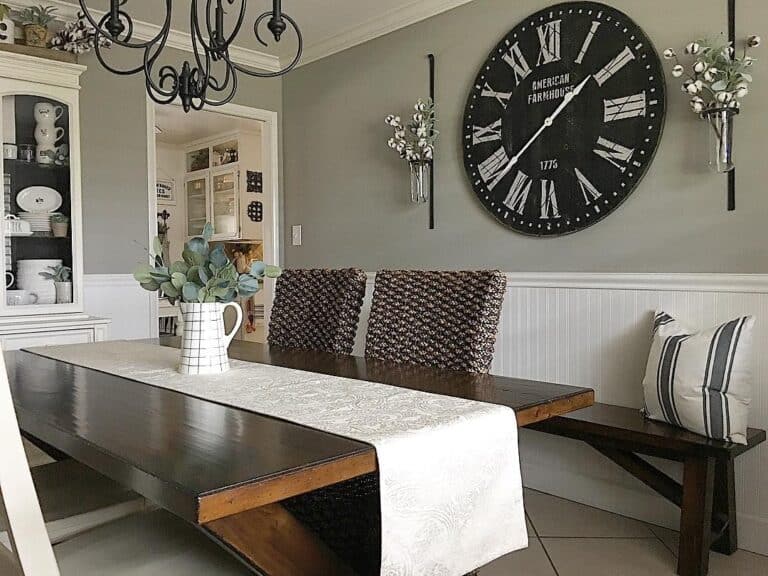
(0, 354, 252, 576)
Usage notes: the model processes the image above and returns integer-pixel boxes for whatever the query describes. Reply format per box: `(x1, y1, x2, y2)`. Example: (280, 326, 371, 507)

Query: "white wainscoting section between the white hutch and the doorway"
(83, 274, 157, 340)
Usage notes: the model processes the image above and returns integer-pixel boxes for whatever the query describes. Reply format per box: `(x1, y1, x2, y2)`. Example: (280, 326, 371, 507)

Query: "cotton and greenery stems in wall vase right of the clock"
(664, 35, 762, 114)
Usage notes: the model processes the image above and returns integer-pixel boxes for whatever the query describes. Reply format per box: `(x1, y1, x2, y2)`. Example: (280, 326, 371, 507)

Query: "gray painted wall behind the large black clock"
(284, 0, 768, 272)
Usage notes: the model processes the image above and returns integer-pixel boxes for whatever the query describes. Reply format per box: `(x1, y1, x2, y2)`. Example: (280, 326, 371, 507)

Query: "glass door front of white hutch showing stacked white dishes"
(2, 94, 75, 314)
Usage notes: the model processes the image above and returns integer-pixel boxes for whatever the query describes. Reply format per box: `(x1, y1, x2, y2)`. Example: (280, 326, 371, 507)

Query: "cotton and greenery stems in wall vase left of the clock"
(385, 98, 440, 162)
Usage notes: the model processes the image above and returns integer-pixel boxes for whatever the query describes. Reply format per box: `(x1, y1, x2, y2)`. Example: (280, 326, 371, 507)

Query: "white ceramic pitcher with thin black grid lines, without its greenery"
(179, 302, 243, 374)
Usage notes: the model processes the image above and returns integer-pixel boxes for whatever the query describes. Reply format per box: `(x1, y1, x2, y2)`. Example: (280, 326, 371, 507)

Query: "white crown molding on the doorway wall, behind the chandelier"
(4, 0, 280, 72)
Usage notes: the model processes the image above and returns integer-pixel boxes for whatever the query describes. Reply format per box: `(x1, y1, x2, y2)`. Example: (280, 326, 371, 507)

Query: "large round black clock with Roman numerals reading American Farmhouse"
(462, 2, 665, 236)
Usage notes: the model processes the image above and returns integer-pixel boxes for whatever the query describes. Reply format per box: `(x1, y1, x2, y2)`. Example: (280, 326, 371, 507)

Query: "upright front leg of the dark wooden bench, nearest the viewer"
(677, 457, 715, 576)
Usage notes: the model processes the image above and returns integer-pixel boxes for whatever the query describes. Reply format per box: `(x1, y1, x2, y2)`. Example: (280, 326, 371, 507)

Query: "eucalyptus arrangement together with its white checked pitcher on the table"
(133, 223, 281, 374)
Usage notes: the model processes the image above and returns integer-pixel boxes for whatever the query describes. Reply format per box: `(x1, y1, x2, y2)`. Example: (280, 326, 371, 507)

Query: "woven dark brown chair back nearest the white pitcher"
(268, 268, 366, 354)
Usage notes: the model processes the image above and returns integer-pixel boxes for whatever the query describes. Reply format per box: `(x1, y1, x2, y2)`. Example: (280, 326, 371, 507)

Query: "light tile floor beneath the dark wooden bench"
(480, 490, 768, 576)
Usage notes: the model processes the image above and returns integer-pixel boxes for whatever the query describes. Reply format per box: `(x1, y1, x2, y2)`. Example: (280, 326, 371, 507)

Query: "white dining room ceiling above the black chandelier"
(16, 0, 471, 64)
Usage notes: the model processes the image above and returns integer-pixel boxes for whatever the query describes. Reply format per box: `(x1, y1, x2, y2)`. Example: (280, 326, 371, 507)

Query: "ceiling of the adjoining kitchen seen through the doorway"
(155, 106, 261, 146)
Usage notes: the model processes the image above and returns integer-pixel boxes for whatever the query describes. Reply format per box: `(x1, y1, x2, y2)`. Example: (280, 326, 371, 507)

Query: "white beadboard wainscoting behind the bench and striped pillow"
(355, 273, 768, 554)
